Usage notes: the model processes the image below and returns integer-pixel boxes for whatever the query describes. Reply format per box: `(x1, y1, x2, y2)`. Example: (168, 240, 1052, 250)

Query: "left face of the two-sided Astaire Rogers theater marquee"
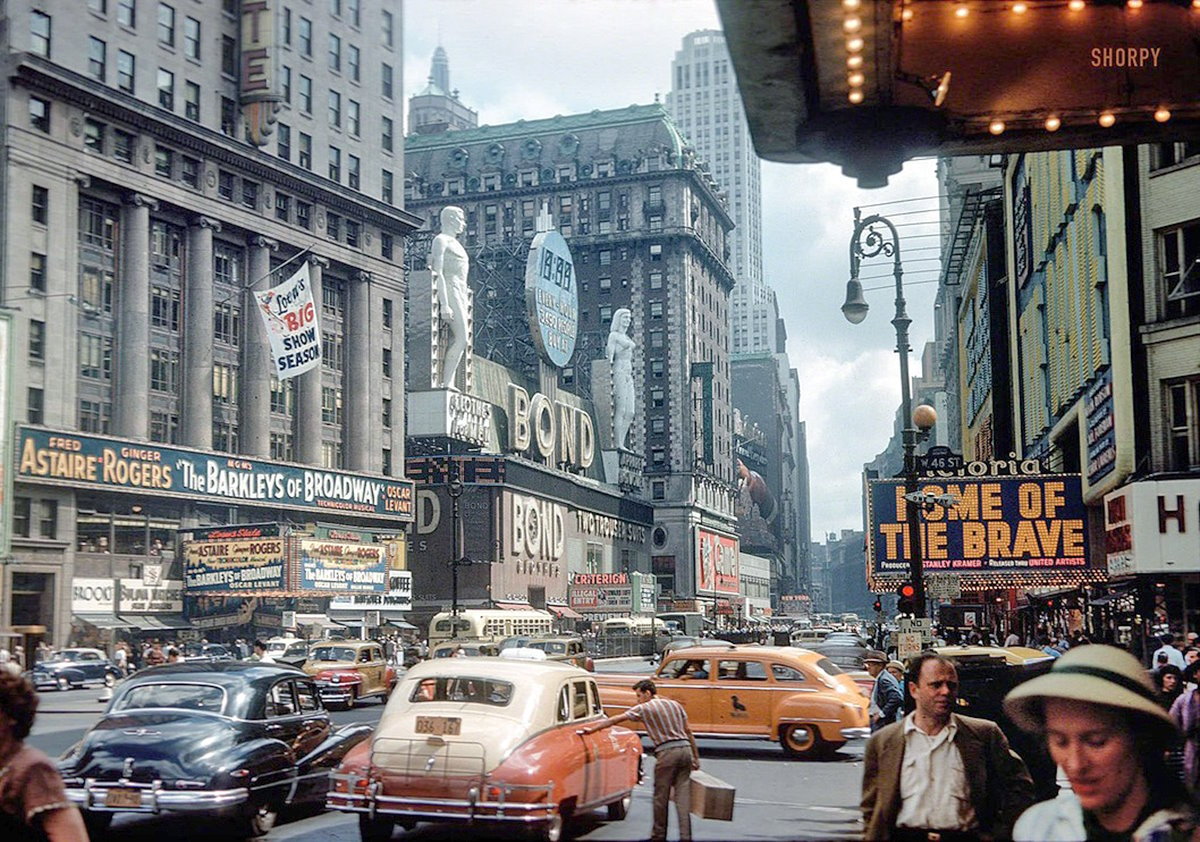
(184, 536, 287, 596)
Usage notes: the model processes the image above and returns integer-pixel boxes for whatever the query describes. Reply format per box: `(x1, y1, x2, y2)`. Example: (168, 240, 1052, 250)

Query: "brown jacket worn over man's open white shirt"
(862, 714, 1033, 840)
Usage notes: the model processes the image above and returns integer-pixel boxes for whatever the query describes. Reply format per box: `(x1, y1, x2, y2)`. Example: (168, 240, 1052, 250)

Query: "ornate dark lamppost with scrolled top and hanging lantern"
(841, 208, 937, 617)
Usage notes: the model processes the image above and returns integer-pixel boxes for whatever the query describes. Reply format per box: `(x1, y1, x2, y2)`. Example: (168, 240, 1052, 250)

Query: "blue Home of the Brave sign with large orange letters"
(866, 474, 1103, 587)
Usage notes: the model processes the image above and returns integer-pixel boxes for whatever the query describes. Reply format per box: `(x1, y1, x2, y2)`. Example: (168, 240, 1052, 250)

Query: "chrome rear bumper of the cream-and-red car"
(325, 772, 558, 824)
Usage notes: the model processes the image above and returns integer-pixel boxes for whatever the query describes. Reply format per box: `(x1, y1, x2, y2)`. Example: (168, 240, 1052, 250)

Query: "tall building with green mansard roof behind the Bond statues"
(404, 104, 738, 614)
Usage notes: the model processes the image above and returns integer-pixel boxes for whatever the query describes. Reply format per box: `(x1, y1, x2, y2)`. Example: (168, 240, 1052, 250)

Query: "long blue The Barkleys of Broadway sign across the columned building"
(17, 427, 415, 522)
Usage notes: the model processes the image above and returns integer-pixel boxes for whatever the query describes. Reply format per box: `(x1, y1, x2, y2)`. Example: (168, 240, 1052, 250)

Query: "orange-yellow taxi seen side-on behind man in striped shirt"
(596, 644, 870, 757)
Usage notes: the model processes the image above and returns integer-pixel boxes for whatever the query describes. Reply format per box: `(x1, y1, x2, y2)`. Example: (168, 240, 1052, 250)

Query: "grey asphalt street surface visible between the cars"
(29, 664, 863, 842)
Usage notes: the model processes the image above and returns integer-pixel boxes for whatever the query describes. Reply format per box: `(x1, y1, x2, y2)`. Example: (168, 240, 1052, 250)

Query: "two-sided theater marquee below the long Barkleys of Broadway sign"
(184, 535, 388, 596)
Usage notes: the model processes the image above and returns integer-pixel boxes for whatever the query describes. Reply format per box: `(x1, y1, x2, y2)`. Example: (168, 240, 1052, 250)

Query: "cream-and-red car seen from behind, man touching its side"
(326, 657, 642, 842)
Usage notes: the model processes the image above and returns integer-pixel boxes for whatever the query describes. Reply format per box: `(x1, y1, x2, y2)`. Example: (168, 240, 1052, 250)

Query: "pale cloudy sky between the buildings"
(403, 0, 938, 541)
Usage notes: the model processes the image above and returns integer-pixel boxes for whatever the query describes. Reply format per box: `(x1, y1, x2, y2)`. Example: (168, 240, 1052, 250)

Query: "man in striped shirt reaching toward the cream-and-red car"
(580, 679, 700, 842)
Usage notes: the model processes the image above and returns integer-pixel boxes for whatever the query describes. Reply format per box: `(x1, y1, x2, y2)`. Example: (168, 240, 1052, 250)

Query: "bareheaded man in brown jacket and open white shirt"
(862, 652, 1033, 842)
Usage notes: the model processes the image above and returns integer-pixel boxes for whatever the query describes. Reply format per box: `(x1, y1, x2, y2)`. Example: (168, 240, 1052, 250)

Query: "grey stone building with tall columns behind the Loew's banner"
(0, 0, 415, 644)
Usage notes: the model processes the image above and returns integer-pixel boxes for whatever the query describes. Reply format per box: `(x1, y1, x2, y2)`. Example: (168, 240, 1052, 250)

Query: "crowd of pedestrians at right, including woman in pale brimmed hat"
(862, 630, 1200, 842)
